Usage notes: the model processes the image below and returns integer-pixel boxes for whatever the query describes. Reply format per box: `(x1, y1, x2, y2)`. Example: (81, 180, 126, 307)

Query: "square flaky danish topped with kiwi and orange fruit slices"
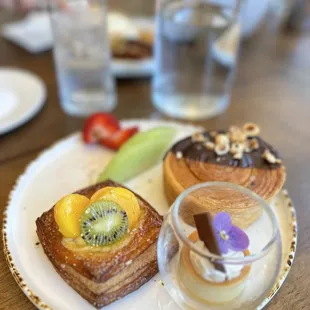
(36, 181, 162, 308)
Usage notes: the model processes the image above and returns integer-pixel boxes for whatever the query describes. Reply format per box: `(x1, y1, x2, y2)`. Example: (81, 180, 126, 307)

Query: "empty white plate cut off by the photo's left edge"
(0, 68, 46, 134)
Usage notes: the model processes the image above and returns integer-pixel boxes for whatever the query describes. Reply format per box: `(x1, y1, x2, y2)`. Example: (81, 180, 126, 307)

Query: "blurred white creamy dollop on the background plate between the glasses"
(108, 13, 140, 40)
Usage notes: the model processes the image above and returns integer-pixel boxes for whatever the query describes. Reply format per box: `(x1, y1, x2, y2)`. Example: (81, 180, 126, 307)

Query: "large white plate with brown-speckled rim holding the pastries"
(3, 120, 296, 310)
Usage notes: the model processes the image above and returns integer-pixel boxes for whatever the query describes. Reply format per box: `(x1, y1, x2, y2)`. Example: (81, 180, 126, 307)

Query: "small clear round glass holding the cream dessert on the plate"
(158, 182, 282, 310)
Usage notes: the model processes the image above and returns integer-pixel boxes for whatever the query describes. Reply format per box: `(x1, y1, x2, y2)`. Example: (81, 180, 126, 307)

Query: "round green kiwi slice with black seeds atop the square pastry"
(80, 200, 128, 247)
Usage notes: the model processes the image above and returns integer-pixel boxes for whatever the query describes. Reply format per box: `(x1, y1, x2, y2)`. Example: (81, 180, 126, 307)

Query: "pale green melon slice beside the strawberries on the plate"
(98, 127, 176, 183)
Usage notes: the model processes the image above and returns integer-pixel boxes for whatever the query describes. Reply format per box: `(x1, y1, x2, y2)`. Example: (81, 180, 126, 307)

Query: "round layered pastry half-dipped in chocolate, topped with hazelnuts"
(163, 124, 286, 228)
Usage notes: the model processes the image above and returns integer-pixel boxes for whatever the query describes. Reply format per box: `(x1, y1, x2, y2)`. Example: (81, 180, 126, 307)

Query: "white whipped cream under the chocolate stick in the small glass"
(190, 240, 244, 283)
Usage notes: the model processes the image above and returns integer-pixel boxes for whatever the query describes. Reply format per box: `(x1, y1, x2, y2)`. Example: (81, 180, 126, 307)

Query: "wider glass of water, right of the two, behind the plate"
(152, 0, 241, 120)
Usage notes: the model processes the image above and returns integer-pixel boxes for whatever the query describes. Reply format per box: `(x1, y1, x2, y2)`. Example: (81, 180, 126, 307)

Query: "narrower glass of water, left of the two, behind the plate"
(50, 0, 116, 116)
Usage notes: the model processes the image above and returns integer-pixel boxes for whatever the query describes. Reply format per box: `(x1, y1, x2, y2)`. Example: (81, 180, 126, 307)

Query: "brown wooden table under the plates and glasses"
(0, 10, 310, 310)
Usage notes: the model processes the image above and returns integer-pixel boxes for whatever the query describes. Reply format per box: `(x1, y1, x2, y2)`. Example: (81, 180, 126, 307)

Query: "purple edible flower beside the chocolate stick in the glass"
(213, 212, 250, 254)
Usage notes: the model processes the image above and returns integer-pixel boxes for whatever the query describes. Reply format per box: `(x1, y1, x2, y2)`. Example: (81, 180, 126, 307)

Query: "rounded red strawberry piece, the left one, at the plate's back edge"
(83, 113, 120, 143)
